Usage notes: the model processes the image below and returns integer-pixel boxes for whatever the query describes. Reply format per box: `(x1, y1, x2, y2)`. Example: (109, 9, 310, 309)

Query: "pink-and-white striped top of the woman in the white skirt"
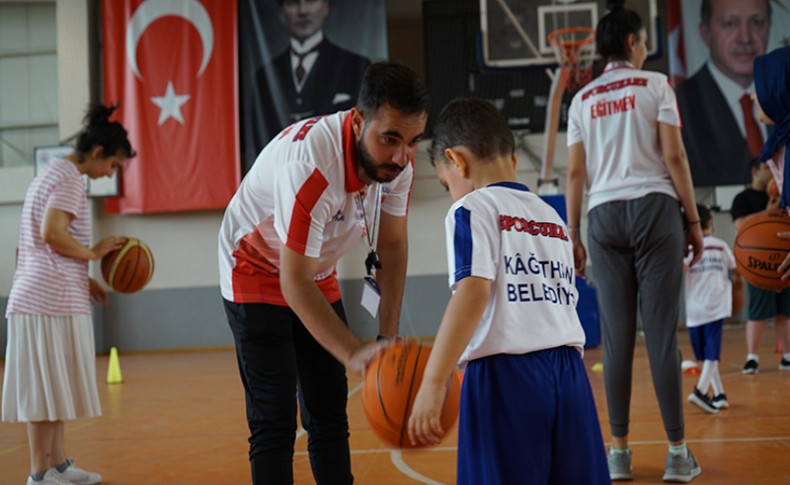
(6, 159, 91, 316)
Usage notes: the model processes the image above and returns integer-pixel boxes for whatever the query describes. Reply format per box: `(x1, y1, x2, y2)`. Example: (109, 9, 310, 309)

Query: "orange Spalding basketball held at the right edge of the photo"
(733, 211, 790, 291)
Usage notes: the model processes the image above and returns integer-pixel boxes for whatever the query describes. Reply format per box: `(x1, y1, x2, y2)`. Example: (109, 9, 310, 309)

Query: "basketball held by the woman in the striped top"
(101, 237, 154, 293)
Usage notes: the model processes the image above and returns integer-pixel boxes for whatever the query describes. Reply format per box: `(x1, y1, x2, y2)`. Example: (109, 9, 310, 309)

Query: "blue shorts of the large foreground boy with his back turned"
(457, 347, 611, 485)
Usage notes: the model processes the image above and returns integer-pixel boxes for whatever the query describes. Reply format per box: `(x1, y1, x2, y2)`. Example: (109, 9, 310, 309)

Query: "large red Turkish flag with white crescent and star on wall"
(102, 0, 241, 214)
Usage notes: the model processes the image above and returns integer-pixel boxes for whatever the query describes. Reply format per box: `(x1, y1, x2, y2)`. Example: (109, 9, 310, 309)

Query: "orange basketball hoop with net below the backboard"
(546, 27, 595, 93)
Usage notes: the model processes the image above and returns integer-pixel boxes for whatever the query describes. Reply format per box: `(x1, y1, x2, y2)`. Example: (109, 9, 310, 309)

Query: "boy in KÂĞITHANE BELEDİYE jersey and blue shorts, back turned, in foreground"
(408, 98, 610, 484)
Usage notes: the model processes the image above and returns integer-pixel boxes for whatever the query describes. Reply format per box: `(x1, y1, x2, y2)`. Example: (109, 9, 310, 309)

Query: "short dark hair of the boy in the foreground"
(428, 97, 516, 167)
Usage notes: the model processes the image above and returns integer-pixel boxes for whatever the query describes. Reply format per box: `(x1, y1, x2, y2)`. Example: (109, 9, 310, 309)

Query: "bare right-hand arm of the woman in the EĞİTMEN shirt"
(658, 122, 703, 266)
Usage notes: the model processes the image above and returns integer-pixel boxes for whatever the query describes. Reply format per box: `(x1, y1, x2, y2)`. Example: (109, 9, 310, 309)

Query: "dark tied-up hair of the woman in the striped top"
(75, 103, 136, 158)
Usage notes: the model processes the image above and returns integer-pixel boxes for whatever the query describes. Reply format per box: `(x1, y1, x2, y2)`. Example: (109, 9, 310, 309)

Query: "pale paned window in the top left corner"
(0, 1, 58, 169)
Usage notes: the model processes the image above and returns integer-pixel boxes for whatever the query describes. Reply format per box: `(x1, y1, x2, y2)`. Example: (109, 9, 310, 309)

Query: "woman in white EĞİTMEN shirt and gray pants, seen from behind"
(566, 1, 702, 482)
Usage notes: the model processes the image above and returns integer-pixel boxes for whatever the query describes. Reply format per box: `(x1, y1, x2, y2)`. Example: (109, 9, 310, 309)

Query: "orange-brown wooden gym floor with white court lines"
(0, 327, 790, 485)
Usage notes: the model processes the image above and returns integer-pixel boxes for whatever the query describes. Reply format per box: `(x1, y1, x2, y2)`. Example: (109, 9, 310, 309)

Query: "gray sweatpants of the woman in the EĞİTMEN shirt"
(588, 194, 686, 442)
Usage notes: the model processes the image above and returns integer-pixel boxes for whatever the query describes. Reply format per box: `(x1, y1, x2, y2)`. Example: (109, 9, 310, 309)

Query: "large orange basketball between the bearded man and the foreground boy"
(362, 340, 461, 448)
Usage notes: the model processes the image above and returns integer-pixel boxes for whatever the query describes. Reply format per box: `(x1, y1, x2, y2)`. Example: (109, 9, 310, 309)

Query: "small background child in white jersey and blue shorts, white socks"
(683, 204, 743, 414)
